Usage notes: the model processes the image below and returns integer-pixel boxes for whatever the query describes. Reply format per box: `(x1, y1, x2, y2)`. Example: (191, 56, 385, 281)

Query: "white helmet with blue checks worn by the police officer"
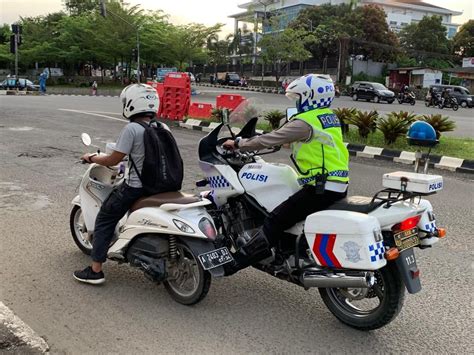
(286, 74, 335, 112)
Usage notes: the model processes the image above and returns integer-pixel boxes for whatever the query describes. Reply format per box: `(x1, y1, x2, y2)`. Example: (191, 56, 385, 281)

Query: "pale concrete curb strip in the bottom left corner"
(0, 302, 49, 353)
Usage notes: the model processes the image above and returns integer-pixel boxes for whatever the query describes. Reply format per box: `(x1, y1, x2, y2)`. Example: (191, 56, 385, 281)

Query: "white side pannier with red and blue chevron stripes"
(304, 210, 387, 270)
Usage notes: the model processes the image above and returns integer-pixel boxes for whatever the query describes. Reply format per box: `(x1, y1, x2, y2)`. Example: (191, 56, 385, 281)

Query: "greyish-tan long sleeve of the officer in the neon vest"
(239, 120, 312, 151)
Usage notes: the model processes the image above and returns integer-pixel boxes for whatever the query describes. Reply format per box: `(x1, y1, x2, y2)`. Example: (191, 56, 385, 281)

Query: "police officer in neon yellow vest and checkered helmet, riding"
(224, 74, 349, 275)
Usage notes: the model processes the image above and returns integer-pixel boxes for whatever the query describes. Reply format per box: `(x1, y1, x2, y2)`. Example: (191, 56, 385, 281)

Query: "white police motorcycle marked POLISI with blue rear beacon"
(197, 101, 446, 330)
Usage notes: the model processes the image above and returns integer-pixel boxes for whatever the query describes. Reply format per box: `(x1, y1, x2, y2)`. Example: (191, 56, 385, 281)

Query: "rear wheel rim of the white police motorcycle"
(327, 271, 386, 318)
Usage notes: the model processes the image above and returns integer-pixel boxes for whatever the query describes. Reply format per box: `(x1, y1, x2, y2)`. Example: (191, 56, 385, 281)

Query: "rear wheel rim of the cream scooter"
(168, 244, 201, 297)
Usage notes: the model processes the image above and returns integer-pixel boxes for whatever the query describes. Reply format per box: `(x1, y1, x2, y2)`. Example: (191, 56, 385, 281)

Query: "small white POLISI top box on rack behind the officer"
(382, 171, 443, 194)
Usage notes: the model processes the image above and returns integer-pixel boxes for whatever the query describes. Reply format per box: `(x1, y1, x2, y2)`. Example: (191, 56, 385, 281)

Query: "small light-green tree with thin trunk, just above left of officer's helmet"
(258, 28, 311, 89)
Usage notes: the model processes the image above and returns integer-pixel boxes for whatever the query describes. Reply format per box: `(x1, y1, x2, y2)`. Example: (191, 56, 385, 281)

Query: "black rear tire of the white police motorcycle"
(319, 263, 405, 331)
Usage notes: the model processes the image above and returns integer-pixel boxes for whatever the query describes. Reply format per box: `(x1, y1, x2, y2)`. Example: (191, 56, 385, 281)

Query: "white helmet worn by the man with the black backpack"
(120, 84, 160, 118)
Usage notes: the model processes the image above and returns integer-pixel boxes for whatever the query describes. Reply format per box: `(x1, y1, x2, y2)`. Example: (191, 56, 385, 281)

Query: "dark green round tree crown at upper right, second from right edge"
(400, 16, 451, 62)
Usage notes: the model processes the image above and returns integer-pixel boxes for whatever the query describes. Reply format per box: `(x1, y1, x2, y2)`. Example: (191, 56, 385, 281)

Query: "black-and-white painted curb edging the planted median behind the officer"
(179, 118, 474, 174)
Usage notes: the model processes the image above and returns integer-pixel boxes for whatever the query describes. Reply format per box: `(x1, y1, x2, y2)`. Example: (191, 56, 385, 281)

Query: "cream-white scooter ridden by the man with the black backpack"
(70, 133, 224, 305)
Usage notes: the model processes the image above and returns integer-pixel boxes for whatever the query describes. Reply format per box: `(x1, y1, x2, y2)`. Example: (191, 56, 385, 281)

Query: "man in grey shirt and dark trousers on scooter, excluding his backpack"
(73, 84, 160, 285)
